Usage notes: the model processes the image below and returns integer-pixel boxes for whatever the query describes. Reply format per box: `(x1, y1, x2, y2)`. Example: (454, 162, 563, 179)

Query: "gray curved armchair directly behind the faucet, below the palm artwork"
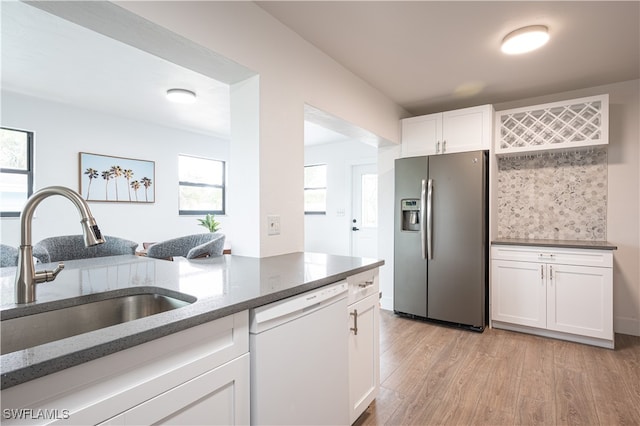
(33, 235, 138, 263)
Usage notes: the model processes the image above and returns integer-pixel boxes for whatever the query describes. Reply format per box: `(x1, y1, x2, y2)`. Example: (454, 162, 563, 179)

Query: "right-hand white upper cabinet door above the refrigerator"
(440, 105, 493, 154)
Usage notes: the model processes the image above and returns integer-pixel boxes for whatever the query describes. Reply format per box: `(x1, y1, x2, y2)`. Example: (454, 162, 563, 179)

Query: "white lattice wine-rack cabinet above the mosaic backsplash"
(495, 95, 609, 155)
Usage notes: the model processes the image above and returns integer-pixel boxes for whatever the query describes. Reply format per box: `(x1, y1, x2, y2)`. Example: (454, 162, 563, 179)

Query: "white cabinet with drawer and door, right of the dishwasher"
(347, 268, 380, 423)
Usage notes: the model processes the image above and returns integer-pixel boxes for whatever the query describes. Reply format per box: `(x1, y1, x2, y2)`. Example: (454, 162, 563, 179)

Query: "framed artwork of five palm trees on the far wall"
(80, 152, 156, 203)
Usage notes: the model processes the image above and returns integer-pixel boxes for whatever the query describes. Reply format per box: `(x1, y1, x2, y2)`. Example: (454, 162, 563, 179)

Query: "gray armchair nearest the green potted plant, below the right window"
(147, 232, 225, 259)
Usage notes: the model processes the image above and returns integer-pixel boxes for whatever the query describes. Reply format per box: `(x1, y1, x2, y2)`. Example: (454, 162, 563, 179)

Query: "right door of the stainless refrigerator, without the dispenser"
(427, 151, 487, 327)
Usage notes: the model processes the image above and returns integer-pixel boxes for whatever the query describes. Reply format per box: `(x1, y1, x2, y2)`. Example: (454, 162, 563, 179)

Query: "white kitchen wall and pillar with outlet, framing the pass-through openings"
(117, 2, 406, 257)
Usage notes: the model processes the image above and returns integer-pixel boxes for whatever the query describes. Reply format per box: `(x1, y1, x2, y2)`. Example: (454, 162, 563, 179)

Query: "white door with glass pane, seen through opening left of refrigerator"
(351, 164, 378, 258)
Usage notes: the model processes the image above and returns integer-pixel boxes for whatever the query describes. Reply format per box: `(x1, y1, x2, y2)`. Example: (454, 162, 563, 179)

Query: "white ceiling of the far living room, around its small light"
(1, 1, 229, 138)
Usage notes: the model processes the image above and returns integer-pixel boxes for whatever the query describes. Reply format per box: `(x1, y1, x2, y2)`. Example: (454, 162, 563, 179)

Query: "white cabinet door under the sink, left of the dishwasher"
(101, 353, 249, 425)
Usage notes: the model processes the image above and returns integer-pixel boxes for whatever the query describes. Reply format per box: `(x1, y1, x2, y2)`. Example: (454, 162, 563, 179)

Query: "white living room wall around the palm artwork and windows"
(0, 91, 229, 247)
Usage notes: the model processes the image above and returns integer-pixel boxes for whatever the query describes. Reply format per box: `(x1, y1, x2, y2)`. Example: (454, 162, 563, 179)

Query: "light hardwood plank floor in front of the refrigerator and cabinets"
(355, 311, 640, 426)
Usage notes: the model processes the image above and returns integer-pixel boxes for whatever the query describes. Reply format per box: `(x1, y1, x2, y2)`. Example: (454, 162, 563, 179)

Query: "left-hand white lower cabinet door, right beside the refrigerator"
(491, 260, 547, 328)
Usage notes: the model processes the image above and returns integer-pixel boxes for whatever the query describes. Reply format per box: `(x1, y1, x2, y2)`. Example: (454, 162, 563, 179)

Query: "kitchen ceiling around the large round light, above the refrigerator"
(257, 1, 640, 115)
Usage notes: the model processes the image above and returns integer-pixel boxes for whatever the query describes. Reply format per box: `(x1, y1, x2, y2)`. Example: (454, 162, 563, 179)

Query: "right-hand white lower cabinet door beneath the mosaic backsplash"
(547, 264, 613, 340)
